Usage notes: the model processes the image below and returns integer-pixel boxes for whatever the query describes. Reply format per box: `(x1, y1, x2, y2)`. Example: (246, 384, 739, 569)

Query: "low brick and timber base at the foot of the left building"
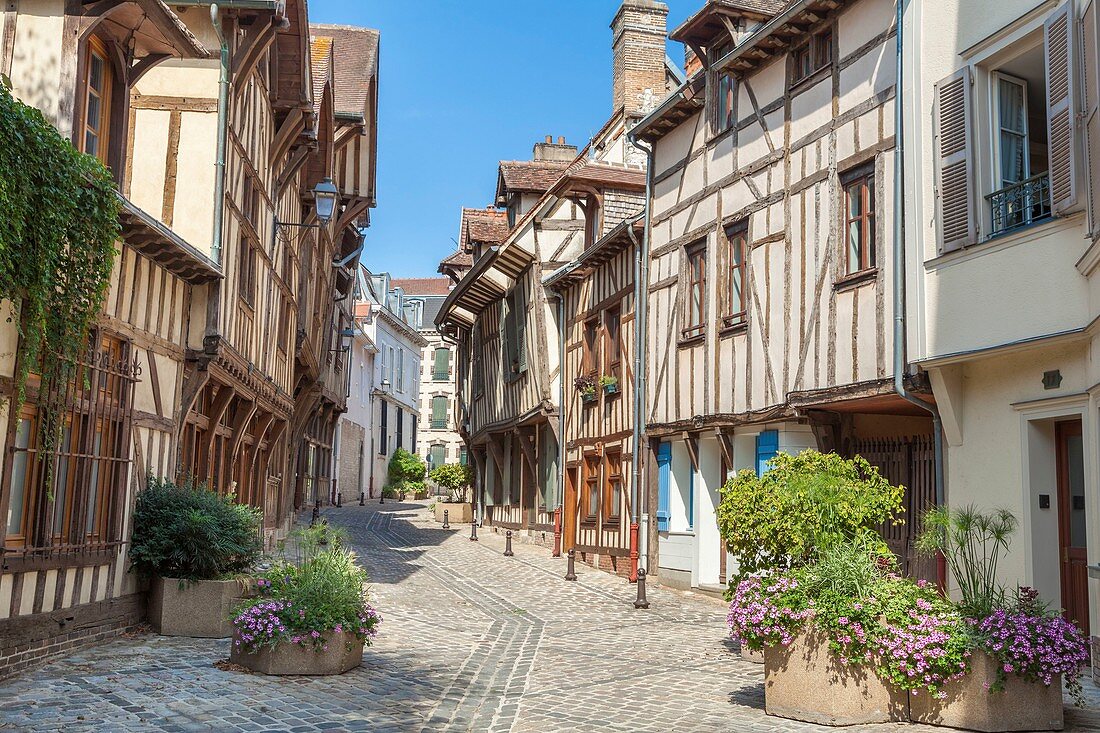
(0, 594, 145, 679)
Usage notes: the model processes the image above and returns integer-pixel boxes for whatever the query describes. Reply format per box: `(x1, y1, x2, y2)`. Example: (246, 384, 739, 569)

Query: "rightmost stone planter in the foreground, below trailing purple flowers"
(910, 652, 1064, 731)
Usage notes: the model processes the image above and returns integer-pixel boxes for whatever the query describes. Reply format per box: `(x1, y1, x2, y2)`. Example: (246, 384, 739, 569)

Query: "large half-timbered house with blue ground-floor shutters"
(635, 0, 934, 589)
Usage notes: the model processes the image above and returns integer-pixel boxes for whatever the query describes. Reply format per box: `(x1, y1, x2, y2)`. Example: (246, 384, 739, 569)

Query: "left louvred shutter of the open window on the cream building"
(933, 66, 977, 254)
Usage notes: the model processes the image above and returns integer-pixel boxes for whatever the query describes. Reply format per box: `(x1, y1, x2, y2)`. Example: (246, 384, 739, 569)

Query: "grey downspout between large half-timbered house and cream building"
(893, 0, 945, 508)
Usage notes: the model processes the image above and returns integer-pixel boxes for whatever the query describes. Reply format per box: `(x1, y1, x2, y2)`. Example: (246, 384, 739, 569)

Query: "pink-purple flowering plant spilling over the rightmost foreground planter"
(971, 588, 1089, 705)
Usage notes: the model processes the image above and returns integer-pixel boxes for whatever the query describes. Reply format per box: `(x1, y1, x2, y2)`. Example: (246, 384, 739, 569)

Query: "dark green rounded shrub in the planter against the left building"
(130, 477, 263, 580)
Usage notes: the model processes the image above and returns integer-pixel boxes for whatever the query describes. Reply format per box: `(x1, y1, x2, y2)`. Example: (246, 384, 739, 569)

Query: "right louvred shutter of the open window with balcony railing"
(1043, 2, 1077, 214)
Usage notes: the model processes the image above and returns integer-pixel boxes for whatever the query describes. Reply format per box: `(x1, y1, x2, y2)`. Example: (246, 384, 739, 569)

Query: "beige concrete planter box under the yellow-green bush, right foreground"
(763, 628, 909, 725)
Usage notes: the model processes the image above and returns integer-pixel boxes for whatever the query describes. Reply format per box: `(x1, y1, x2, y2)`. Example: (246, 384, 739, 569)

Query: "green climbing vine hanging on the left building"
(0, 80, 119, 466)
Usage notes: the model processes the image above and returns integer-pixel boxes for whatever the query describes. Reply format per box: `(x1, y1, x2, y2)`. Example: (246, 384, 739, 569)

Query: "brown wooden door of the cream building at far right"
(1055, 419, 1089, 636)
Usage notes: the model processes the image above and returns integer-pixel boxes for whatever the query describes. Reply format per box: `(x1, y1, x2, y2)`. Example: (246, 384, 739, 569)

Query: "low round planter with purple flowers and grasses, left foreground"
(230, 527, 382, 675)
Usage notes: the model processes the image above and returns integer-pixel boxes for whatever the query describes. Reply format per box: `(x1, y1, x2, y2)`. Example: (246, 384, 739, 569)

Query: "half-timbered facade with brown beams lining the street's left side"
(0, 0, 378, 676)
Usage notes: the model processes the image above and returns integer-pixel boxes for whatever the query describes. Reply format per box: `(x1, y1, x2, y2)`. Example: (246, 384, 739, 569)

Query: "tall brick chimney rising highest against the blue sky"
(612, 0, 669, 118)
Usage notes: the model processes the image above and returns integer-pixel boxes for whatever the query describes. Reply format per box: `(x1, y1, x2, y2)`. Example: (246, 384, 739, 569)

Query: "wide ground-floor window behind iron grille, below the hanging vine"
(4, 332, 136, 550)
